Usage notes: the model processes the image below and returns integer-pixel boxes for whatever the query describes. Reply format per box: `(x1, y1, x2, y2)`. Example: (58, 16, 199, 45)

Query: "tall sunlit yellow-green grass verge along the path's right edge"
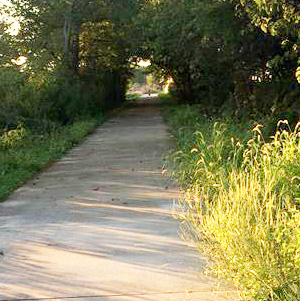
(166, 107, 300, 301)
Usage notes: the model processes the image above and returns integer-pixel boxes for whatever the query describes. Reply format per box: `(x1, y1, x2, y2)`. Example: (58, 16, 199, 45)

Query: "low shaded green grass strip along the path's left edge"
(0, 116, 104, 200)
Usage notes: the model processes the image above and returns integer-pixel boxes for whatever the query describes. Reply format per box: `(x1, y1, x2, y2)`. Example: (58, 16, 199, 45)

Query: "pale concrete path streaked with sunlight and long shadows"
(0, 97, 234, 301)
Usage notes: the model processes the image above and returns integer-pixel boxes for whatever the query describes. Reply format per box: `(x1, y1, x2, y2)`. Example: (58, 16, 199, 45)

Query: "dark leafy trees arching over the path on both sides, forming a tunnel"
(0, 0, 300, 128)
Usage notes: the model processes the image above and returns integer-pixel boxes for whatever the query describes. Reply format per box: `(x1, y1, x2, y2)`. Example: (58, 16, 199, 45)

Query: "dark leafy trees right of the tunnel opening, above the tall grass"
(138, 0, 300, 122)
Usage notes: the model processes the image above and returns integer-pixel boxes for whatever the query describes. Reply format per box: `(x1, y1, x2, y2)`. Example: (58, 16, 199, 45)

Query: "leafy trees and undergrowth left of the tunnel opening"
(0, 0, 140, 127)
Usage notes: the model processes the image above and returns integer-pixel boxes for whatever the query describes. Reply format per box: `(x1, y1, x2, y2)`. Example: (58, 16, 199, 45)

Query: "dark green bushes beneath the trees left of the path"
(0, 67, 125, 132)
